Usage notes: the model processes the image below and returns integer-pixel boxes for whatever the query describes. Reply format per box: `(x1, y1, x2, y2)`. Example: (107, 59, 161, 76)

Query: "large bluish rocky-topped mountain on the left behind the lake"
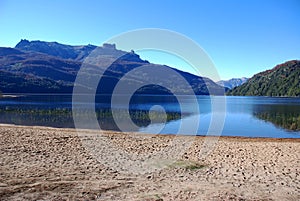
(0, 40, 224, 95)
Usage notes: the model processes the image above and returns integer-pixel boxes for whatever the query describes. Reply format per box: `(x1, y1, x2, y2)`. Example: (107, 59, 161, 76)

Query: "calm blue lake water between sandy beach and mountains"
(0, 95, 300, 138)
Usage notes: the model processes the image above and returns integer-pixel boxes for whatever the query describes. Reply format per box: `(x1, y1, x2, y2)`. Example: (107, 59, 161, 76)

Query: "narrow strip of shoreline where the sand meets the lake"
(0, 123, 300, 142)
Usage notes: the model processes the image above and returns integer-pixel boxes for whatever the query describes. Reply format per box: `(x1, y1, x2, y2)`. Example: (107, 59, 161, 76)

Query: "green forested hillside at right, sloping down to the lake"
(227, 60, 300, 96)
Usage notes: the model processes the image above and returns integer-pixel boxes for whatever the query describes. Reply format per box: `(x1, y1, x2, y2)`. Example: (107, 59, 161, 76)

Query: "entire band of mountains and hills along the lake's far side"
(0, 40, 300, 96)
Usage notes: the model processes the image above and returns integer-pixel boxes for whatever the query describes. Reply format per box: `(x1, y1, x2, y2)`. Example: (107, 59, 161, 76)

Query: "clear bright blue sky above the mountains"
(0, 0, 300, 79)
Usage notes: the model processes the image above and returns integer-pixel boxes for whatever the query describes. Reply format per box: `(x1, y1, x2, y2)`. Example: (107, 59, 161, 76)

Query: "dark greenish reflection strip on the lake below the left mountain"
(0, 106, 182, 131)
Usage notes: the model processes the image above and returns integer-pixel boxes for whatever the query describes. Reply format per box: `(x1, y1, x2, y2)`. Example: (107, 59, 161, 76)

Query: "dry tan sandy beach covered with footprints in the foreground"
(0, 125, 300, 201)
